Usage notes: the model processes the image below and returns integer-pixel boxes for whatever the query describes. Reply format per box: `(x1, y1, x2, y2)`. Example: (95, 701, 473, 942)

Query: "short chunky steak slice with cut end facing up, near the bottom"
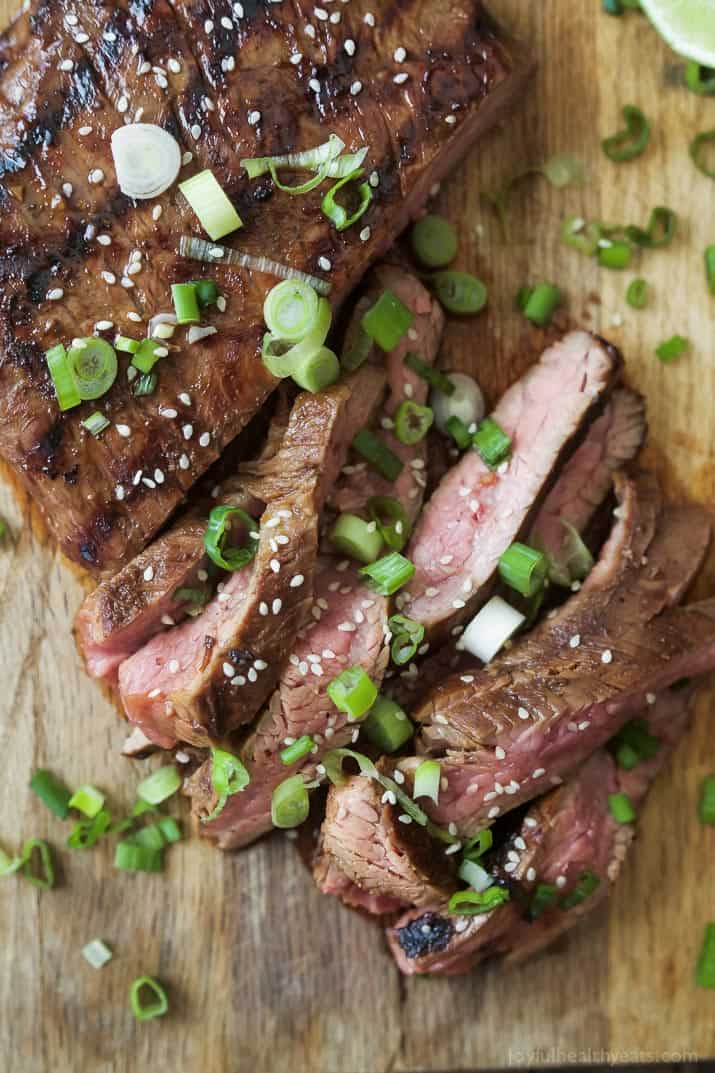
(321, 775, 457, 906)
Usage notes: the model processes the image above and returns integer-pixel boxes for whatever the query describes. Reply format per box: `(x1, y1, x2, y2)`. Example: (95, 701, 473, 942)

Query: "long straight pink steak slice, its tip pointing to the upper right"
(400, 332, 622, 643)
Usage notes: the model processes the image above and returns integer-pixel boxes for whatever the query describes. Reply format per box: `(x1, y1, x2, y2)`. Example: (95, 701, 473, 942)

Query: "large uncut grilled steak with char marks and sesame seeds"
(0, 0, 529, 574)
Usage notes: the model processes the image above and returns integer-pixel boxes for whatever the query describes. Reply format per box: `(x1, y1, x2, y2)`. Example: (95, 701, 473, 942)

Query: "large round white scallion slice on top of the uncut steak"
(112, 123, 181, 200)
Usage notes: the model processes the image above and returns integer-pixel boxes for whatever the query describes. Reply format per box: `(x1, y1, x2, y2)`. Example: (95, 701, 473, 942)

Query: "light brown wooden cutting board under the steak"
(0, 0, 715, 1073)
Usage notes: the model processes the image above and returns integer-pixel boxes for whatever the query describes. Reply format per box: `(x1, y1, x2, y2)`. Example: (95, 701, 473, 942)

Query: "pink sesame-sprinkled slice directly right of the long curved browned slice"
(187, 558, 388, 850)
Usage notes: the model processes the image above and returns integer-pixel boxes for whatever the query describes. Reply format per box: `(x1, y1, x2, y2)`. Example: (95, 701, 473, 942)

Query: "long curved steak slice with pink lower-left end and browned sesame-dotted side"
(119, 366, 384, 747)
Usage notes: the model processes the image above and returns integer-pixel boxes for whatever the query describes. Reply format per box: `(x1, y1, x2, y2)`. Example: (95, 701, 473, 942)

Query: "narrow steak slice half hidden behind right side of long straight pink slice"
(529, 388, 646, 584)
